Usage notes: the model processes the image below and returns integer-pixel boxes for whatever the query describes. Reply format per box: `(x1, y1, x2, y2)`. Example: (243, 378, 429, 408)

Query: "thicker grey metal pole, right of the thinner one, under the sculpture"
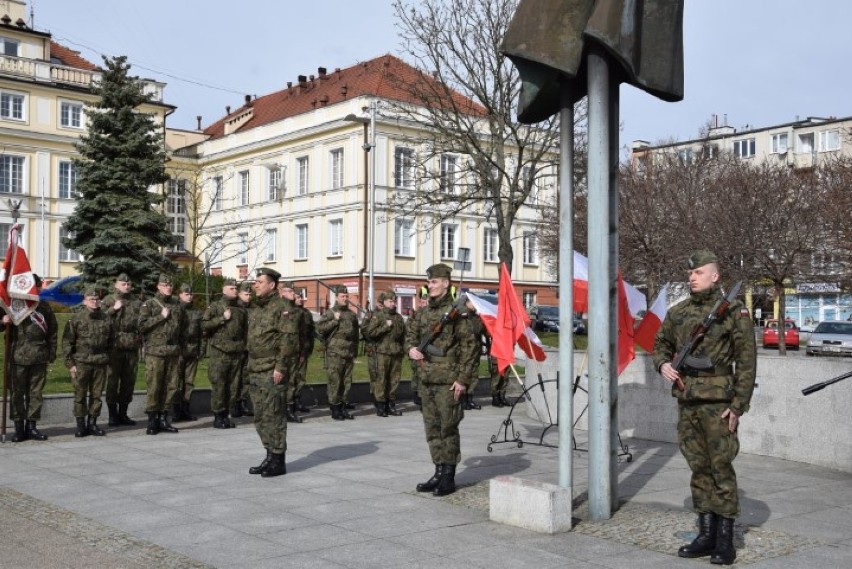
(588, 48, 614, 520)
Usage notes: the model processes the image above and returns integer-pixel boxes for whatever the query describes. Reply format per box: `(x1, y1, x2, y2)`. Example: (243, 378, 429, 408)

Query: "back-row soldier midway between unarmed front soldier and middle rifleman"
(317, 285, 358, 421)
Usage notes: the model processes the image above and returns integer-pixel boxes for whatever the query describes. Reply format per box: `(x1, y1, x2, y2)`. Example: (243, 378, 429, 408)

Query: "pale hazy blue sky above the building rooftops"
(31, 0, 852, 156)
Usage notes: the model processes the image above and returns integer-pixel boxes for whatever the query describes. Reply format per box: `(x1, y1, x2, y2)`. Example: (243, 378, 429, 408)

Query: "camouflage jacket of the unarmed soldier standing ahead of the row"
(246, 292, 300, 372)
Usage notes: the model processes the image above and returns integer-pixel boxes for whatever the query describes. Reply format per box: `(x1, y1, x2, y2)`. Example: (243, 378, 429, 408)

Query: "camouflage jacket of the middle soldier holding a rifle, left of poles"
(405, 294, 479, 387)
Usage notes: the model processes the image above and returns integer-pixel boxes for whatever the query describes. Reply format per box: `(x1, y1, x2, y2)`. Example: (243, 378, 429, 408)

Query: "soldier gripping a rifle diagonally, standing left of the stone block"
(405, 264, 478, 496)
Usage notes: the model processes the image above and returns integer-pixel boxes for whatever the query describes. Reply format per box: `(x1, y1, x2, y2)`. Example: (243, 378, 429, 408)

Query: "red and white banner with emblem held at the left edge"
(0, 223, 38, 326)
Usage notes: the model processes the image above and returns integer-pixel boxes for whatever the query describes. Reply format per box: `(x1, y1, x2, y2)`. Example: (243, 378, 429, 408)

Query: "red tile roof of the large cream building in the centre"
(204, 55, 486, 138)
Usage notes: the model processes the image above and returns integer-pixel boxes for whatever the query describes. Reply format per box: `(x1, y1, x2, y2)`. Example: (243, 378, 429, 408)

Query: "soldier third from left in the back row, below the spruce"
(101, 273, 142, 427)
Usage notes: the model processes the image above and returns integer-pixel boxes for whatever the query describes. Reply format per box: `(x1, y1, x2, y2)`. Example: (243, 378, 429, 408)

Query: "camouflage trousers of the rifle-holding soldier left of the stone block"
(420, 384, 464, 464)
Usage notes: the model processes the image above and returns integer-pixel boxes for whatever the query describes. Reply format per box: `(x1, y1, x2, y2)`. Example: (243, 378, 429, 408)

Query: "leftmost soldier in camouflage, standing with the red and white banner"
(2, 274, 59, 442)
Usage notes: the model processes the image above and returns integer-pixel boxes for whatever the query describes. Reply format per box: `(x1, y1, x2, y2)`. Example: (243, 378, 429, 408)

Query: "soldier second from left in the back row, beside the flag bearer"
(62, 287, 115, 437)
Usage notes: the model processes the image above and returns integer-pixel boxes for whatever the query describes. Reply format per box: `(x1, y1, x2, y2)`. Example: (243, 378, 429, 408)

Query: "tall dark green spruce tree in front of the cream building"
(63, 56, 175, 286)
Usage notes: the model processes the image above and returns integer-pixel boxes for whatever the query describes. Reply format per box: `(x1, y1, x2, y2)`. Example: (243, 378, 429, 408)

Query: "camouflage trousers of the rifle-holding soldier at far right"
(677, 402, 740, 518)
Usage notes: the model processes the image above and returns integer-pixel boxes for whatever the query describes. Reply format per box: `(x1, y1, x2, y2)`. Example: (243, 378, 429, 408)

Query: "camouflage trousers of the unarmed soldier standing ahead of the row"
(247, 370, 290, 454)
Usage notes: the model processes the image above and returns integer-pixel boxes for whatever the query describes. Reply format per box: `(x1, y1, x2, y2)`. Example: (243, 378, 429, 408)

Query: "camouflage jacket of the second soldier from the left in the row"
(62, 308, 115, 369)
